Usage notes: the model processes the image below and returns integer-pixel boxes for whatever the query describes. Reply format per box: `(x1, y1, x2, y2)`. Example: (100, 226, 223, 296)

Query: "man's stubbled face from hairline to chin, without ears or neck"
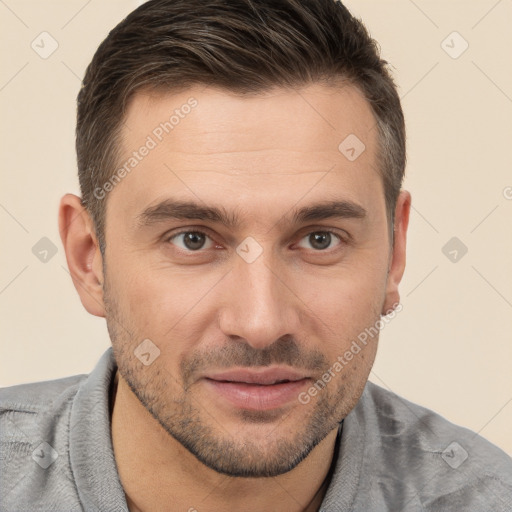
(103, 84, 391, 477)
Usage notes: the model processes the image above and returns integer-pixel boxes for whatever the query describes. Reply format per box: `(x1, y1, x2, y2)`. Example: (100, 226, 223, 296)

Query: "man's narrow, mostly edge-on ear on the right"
(381, 190, 411, 315)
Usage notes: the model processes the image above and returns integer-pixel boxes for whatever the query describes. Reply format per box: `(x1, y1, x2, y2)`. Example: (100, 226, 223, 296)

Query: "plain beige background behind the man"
(0, 0, 512, 454)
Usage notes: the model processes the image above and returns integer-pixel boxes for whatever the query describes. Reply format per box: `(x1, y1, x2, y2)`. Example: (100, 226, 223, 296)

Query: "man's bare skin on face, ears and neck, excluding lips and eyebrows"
(59, 84, 411, 512)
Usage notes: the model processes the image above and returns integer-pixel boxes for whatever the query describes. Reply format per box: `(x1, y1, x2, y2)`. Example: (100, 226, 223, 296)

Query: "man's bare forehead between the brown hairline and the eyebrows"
(108, 84, 382, 227)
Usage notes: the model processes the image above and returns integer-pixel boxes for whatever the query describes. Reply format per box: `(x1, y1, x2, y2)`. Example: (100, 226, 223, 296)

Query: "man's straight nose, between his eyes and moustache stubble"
(219, 252, 302, 349)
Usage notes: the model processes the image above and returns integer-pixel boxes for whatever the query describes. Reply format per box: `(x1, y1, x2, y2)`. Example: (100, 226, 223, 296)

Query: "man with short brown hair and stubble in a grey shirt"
(0, 0, 512, 512)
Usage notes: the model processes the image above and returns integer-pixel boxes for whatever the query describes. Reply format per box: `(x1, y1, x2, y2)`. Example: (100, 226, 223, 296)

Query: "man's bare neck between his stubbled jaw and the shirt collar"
(112, 373, 337, 512)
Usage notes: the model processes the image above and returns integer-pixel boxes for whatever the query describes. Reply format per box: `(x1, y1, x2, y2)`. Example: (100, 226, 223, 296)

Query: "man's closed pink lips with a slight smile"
(203, 368, 310, 411)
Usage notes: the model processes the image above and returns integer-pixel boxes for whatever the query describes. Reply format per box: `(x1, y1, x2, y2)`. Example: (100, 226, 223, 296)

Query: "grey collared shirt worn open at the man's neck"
(0, 348, 512, 512)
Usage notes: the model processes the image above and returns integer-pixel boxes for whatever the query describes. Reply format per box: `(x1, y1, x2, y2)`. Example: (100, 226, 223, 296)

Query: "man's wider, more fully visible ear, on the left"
(59, 194, 105, 317)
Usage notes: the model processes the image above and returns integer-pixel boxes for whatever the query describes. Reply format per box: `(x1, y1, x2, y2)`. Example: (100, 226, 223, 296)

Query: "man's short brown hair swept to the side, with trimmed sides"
(76, 0, 406, 252)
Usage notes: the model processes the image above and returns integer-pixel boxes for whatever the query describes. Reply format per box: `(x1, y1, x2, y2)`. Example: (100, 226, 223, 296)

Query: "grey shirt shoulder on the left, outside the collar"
(0, 375, 87, 511)
